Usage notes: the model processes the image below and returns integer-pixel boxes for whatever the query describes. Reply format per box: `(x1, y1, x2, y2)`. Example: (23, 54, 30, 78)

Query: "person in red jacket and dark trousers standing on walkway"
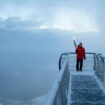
(76, 42, 86, 71)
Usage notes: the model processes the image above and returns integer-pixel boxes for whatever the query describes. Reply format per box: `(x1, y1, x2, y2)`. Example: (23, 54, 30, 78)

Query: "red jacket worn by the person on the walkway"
(76, 46, 85, 60)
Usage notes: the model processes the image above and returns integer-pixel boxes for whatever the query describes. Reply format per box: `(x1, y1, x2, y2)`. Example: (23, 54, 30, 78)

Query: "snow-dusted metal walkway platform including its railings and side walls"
(44, 52, 105, 105)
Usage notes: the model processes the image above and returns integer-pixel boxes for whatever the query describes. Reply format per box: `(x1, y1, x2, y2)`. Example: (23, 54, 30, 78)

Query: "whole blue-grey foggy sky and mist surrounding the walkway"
(0, 0, 105, 105)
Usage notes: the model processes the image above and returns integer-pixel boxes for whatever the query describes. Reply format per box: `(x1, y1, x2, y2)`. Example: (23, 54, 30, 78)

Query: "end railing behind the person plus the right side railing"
(59, 52, 105, 86)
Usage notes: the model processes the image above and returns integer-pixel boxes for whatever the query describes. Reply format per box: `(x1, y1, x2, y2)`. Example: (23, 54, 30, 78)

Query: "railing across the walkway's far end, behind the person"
(59, 52, 96, 70)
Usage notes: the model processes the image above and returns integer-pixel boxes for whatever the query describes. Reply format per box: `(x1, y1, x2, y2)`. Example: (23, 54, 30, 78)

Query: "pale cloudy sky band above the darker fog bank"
(0, 0, 105, 32)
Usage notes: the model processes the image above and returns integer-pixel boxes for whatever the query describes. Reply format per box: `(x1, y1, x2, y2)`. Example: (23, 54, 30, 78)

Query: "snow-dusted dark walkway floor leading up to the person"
(70, 71, 105, 105)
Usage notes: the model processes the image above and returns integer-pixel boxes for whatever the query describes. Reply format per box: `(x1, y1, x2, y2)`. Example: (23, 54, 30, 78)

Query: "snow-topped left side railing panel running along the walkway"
(45, 57, 70, 105)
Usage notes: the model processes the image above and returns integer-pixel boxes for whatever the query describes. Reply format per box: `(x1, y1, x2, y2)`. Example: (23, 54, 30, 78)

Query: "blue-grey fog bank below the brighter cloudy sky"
(0, 30, 105, 100)
